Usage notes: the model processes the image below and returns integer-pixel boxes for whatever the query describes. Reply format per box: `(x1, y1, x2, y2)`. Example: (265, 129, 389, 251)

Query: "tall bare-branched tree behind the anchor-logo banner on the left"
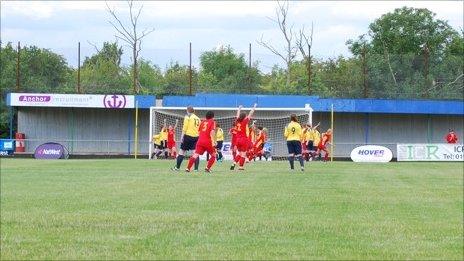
(106, 0, 155, 93)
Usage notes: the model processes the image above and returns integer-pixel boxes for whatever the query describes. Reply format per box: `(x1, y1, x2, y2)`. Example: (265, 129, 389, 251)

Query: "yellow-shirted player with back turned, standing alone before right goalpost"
(284, 114, 304, 171)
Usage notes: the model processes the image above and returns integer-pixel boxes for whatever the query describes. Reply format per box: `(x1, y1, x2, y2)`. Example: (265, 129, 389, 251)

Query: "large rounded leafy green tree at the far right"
(347, 7, 462, 98)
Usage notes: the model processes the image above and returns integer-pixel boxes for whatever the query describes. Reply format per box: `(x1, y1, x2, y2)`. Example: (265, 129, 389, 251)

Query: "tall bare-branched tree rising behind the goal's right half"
(258, 1, 298, 88)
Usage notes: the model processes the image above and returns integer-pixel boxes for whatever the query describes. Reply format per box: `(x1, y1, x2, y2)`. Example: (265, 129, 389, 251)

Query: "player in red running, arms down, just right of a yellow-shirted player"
(185, 111, 216, 172)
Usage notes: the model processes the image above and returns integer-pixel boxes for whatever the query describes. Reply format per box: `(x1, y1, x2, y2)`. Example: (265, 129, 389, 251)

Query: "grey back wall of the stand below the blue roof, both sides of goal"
(18, 107, 464, 157)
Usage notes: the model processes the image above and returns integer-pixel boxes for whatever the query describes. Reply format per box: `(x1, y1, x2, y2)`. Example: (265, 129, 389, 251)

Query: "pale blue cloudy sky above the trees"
(0, 1, 464, 72)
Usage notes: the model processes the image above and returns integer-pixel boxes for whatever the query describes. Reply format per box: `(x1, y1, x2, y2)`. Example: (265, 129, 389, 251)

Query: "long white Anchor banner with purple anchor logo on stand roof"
(9, 93, 135, 109)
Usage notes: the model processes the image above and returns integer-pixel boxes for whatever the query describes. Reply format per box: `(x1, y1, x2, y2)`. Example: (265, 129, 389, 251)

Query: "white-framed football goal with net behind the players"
(149, 104, 313, 159)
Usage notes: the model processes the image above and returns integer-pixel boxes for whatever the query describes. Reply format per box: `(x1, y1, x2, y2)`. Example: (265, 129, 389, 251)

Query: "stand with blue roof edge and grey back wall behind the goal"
(10, 94, 464, 157)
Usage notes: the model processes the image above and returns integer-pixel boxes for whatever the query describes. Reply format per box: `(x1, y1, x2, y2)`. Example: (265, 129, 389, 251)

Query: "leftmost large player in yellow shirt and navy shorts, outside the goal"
(171, 106, 200, 171)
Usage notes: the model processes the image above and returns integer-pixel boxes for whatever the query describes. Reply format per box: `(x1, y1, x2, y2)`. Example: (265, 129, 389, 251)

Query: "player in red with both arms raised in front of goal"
(230, 103, 257, 170)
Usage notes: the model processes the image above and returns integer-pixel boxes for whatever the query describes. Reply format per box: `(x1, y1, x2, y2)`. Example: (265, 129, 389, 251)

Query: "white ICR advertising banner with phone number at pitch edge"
(396, 143, 464, 161)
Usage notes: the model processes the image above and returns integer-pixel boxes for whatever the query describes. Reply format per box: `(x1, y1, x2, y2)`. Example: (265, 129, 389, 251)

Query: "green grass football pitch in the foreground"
(0, 159, 464, 260)
